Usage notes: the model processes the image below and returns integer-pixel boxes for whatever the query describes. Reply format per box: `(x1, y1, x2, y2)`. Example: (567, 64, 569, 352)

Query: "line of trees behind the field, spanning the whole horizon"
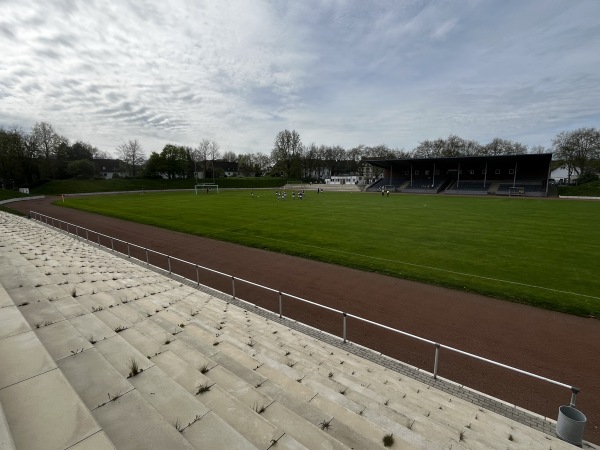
(0, 122, 600, 187)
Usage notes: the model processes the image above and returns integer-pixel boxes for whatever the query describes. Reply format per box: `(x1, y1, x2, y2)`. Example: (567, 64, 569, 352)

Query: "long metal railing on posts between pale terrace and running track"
(29, 211, 580, 407)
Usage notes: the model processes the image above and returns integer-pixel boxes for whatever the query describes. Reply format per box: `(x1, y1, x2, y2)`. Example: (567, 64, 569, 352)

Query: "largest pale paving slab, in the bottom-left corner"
(0, 369, 100, 450)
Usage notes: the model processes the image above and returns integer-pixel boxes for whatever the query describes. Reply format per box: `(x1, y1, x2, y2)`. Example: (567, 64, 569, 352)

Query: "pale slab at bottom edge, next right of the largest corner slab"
(93, 390, 194, 450)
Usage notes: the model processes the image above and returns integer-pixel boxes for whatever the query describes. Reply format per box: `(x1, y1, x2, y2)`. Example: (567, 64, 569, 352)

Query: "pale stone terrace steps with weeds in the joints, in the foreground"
(0, 212, 584, 450)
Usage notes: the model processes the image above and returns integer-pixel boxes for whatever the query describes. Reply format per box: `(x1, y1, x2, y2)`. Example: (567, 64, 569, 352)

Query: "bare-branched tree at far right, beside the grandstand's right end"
(552, 128, 600, 182)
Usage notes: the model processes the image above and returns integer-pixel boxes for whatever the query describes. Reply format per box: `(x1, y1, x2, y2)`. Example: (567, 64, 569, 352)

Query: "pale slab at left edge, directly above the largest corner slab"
(0, 331, 56, 389)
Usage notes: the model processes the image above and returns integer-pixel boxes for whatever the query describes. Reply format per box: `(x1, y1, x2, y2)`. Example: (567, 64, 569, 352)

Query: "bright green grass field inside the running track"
(60, 189, 600, 317)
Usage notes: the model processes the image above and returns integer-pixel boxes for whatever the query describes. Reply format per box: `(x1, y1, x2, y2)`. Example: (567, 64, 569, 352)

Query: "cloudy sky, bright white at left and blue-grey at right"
(0, 0, 600, 154)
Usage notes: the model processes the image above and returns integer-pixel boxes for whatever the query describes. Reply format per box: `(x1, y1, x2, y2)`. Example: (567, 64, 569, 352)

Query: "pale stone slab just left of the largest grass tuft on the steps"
(57, 348, 133, 410)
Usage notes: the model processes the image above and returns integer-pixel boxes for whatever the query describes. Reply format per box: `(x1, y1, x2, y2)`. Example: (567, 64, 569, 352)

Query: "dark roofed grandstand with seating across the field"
(366, 153, 552, 197)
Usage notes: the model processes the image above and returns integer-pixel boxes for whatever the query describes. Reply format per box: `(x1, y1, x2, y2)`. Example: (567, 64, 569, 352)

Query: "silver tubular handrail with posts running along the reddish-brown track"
(29, 211, 580, 407)
